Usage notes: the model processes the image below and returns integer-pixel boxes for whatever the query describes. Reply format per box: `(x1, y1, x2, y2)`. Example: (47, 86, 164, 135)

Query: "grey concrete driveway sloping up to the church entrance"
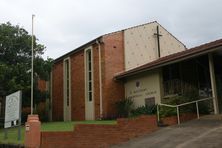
(112, 115, 222, 148)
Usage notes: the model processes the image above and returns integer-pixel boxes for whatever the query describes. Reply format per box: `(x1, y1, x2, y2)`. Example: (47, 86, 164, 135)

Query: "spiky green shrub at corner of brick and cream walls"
(116, 98, 134, 117)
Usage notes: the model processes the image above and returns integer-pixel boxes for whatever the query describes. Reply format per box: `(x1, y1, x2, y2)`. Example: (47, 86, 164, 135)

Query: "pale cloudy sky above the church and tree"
(0, 0, 222, 59)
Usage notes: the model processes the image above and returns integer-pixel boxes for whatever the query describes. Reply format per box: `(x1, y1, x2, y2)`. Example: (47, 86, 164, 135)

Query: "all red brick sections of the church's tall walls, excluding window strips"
(52, 32, 124, 120)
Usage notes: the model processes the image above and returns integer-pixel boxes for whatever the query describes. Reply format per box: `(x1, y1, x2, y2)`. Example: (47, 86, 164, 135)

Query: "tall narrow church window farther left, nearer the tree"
(64, 59, 70, 106)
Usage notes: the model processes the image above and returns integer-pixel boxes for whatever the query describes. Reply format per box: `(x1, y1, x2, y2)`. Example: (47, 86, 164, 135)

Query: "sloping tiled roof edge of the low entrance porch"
(114, 39, 222, 80)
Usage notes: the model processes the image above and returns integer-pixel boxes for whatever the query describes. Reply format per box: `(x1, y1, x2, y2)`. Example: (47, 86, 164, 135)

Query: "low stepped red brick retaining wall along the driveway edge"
(41, 116, 158, 148)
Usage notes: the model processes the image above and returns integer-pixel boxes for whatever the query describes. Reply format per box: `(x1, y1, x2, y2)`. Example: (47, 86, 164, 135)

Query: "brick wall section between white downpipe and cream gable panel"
(102, 32, 125, 118)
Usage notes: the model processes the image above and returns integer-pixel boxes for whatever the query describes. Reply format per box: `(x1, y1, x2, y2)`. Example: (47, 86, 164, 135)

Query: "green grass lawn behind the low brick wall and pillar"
(0, 120, 116, 144)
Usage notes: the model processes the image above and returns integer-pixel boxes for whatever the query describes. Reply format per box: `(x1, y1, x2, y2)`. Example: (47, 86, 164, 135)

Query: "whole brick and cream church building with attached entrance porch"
(51, 22, 222, 121)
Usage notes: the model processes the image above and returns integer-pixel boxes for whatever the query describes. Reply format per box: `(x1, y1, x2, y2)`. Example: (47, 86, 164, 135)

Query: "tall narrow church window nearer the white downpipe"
(86, 49, 92, 102)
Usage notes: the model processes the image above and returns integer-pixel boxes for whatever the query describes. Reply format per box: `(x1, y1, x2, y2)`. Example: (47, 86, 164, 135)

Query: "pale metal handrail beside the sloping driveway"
(157, 97, 214, 124)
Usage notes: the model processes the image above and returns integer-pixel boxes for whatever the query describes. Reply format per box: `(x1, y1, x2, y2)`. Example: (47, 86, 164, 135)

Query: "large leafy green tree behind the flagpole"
(0, 22, 52, 110)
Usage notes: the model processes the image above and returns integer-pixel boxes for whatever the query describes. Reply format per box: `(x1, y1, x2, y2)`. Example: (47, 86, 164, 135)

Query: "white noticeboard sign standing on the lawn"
(4, 91, 22, 128)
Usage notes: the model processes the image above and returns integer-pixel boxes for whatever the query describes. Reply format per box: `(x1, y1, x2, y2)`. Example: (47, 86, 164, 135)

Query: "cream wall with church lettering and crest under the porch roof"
(125, 71, 160, 107)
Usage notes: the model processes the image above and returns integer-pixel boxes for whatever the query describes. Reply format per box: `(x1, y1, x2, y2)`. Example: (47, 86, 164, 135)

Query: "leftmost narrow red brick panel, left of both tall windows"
(52, 61, 63, 120)
